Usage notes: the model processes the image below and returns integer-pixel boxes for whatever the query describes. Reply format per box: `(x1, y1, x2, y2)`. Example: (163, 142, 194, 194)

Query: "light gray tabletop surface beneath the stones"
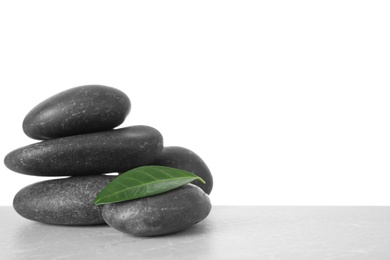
(0, 206, 390, 260)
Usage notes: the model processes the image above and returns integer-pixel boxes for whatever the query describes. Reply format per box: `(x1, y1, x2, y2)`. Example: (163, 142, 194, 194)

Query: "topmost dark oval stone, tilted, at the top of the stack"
(23, 85, 131, 140)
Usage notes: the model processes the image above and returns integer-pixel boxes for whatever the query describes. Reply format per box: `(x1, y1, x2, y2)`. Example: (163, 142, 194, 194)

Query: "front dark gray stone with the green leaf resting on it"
(102, 184, 211, 236)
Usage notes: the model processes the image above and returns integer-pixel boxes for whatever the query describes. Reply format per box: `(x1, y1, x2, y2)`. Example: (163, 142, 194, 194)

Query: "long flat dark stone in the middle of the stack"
(4, 126, 163, 176)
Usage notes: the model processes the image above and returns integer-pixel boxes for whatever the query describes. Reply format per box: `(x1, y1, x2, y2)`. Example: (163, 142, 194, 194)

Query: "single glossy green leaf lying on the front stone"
(95, 165, 206, 204)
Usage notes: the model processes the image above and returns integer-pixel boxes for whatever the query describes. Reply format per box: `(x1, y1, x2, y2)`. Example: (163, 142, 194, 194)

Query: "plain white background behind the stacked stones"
(0, 0, 390, 205)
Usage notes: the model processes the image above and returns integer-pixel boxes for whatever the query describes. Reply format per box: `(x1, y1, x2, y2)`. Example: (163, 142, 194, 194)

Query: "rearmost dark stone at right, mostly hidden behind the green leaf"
(150, 146, 213, 194)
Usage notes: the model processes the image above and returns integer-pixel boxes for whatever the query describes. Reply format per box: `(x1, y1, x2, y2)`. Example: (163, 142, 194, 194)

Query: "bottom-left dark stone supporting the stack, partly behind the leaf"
(13, 175, 115, 225)
